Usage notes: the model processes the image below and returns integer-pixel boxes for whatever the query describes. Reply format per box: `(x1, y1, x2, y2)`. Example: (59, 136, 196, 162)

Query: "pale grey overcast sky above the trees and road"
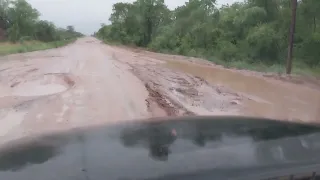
(27, 0, 238, 35)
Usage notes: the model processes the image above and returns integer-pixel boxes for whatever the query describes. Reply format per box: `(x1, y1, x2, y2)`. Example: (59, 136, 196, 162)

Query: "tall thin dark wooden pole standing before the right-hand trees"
(286, 0, 297, 74)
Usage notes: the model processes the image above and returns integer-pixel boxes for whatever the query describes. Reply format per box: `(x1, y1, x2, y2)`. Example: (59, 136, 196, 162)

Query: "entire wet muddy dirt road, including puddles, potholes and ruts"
(0, 37, 320, 141)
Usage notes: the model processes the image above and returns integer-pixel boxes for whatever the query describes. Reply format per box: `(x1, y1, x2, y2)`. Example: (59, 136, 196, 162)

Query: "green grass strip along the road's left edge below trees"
(0, 39, 76, 56)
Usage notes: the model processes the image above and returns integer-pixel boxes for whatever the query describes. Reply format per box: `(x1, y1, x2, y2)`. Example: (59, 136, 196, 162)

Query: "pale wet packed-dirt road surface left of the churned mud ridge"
(0, 38, 149, 142)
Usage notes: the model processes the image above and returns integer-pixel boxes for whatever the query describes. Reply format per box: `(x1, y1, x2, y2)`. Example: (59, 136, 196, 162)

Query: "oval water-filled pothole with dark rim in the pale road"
(11, 74, 74, 96)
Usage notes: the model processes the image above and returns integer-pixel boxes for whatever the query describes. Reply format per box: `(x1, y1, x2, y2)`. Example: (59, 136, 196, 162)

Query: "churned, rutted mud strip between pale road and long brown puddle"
(107, 46, 243, 116)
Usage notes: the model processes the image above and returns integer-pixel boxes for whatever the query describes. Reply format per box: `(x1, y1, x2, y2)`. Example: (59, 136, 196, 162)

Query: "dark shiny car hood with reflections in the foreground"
(0, 117, 320, 180)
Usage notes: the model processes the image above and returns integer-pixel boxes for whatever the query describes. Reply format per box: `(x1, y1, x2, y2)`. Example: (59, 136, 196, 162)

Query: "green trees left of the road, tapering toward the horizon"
(0, 0, 82, 42)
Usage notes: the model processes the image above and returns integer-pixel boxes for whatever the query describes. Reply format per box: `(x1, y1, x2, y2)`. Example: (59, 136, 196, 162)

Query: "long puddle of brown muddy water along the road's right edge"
(166, 61, 320, 122)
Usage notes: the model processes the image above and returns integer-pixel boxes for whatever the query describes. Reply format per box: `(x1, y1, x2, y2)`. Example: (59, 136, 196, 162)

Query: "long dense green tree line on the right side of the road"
(95, 0, 320, 73)
